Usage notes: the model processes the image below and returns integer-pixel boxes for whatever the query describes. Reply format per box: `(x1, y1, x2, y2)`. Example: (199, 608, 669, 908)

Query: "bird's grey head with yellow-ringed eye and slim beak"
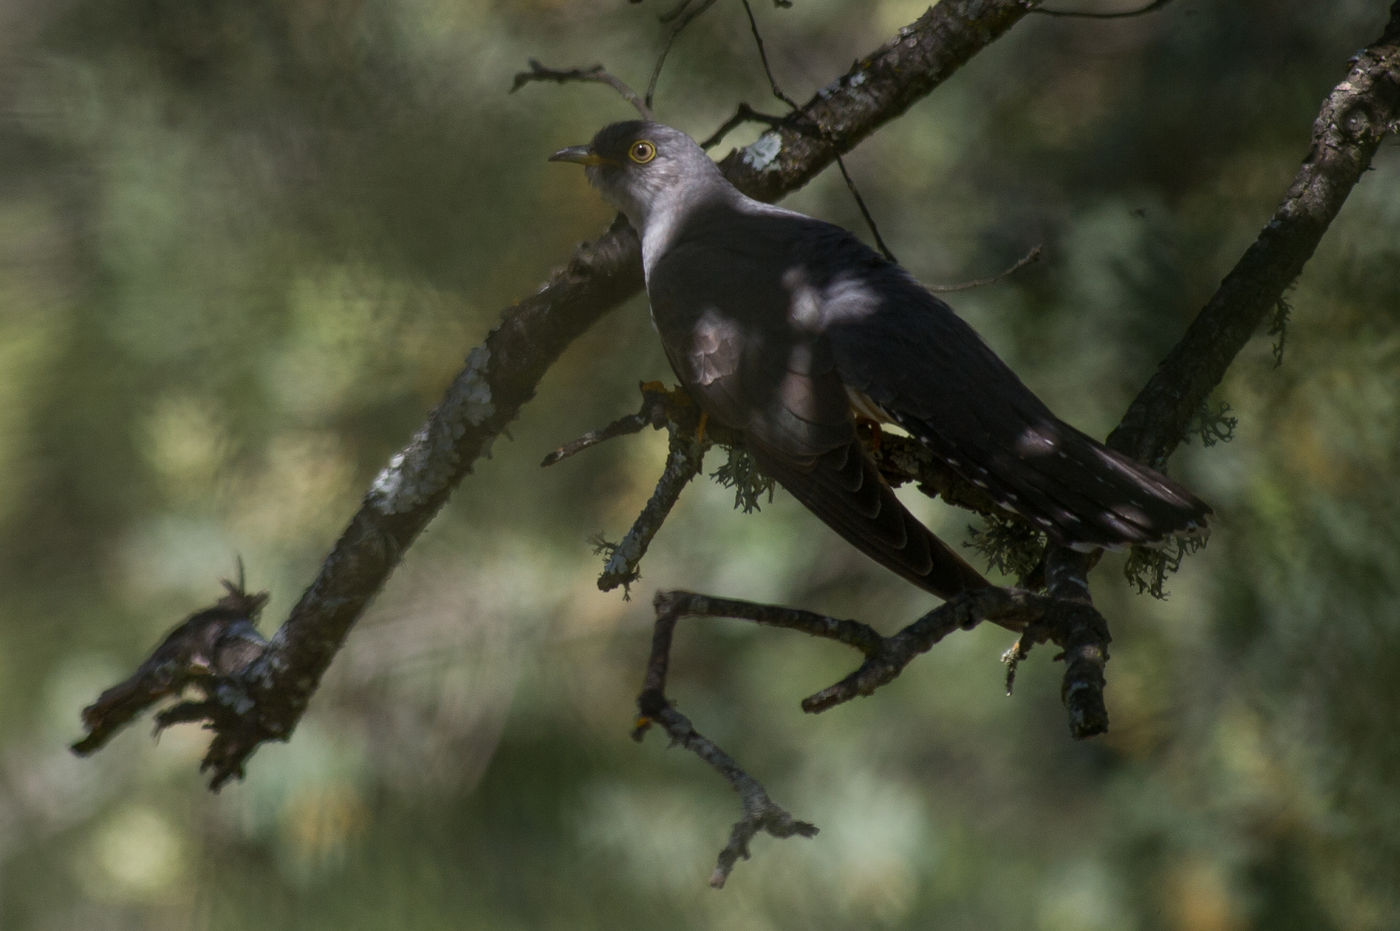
(549, 120, 732, 235)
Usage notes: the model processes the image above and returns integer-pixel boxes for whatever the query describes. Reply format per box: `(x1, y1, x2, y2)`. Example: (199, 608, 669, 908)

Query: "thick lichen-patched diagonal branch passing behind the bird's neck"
(71, 0, 1039, 788)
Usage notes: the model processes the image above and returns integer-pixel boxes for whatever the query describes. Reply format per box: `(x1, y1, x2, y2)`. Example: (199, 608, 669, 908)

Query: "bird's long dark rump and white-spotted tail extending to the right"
(818, 224, 1211, 549)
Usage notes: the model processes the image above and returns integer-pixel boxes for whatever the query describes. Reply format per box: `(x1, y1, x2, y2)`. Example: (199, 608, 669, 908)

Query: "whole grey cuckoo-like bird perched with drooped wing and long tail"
(550, 120, 1211, 598)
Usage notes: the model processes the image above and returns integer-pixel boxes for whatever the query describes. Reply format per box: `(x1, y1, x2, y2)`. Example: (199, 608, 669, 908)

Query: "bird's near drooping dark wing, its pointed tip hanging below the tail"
(647, 205, 987, 598)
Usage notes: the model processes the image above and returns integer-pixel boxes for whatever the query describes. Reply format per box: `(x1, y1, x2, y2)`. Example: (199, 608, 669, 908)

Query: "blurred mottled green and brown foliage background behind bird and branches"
(0, 0, 1400, 931)
